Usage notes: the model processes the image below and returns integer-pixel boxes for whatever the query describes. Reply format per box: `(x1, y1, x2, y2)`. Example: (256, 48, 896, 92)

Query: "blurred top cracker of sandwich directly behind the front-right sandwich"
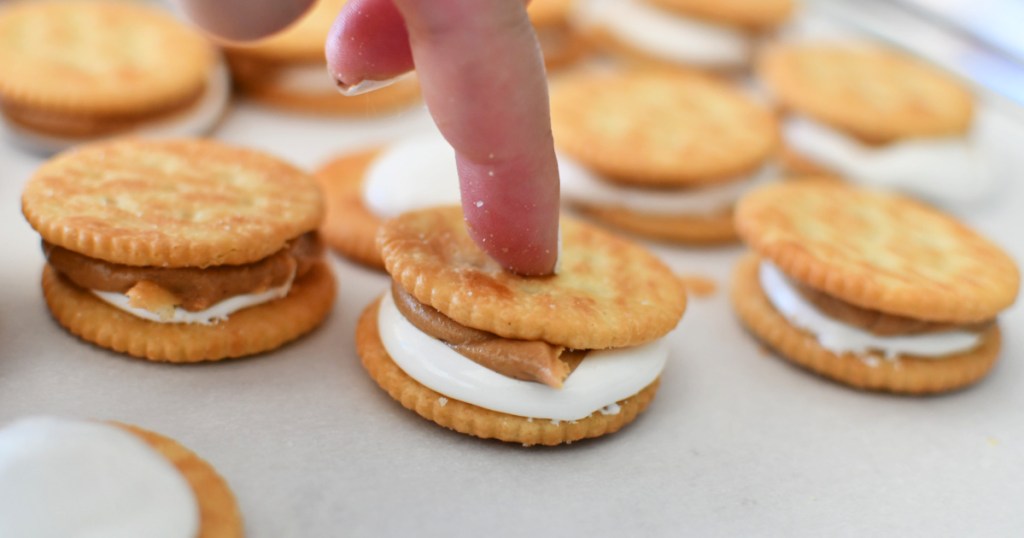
(758, 43, 974, 143)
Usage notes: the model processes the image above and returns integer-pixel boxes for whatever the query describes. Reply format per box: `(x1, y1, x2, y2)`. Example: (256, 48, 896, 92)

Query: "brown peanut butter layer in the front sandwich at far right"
(791, 281, 992, 336)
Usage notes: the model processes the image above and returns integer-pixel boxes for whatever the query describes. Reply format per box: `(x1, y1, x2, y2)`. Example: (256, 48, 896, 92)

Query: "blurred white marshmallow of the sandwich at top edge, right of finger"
(572, 0, 753, 68)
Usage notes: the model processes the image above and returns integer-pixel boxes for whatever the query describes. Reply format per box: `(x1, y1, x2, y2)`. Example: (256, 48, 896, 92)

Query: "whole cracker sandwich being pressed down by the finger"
(356, 207, 686, 445)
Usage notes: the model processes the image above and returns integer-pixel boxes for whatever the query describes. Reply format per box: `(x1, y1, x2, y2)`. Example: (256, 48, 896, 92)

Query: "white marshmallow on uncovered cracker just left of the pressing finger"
(362, 131, 461, 218)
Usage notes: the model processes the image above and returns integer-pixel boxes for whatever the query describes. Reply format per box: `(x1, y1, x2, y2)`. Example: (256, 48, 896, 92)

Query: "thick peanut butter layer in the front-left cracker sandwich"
(43, 232, 324, 312)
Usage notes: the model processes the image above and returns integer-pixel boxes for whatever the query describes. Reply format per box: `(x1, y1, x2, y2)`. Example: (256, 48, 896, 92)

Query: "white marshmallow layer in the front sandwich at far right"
(759, 261, 981, 359)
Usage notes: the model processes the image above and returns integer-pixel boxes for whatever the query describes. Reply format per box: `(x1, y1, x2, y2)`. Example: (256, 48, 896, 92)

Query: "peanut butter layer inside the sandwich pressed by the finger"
(391, 282, 587, 388)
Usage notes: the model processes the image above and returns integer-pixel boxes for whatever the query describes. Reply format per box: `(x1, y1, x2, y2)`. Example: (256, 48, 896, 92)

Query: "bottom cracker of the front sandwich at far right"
(731, 254, 1000, 395)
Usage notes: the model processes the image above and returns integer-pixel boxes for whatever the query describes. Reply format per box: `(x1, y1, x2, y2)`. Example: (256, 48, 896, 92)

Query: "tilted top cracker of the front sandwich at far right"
(736, 181, 1020, 324)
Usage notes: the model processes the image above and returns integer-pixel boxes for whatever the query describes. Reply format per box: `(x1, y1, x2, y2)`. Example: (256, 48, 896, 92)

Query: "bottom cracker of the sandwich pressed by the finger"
(355, 299, 659, 446)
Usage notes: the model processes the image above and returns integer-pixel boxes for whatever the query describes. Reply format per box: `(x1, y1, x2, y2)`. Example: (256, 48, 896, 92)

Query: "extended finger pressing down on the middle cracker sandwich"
(370, 0, 558, 275)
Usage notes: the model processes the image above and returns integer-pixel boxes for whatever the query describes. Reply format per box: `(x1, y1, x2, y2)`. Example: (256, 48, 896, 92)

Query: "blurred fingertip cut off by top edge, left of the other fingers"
(174, 0, 316, 42)
